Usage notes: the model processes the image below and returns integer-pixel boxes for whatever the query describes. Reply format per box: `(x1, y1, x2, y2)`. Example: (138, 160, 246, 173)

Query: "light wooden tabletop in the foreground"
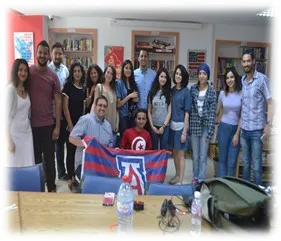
(6, 192, 210, 234)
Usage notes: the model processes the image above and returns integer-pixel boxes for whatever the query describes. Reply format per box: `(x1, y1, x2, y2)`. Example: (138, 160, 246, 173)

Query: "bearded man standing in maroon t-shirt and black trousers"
(30, 40, 62, 192)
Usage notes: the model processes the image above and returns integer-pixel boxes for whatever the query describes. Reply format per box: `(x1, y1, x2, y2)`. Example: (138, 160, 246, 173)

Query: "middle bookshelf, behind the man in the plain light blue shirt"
(132, 31, 179, 76)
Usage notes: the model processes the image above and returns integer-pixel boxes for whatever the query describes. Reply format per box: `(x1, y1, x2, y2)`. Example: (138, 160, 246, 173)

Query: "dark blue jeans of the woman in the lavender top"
(218, 122, 240, 177)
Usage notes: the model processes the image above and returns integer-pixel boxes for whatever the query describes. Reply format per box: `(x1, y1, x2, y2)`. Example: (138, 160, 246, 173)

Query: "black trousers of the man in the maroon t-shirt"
(32, 125, 56, 192)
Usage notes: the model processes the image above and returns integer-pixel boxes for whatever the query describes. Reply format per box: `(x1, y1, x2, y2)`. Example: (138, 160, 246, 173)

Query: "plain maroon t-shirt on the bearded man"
(29, 65, 61, 127)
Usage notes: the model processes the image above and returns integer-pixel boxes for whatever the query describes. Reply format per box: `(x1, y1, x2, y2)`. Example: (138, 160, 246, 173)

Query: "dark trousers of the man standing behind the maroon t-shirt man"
(56, 120, 69, 178)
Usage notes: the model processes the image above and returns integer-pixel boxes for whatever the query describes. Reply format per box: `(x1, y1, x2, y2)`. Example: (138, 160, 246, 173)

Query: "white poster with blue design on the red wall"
(14, 32, 34, 65)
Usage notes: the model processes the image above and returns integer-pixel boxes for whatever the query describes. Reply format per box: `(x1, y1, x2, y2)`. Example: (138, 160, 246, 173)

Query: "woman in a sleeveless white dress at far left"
(7, 59, 34, 167)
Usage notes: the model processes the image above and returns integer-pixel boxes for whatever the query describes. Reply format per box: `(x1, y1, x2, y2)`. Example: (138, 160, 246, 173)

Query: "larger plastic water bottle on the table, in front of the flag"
(117, 176, 134, 232)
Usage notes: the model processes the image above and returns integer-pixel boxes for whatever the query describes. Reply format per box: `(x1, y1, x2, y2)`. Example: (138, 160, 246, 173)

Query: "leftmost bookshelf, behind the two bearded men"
(49, 28, 97, 69)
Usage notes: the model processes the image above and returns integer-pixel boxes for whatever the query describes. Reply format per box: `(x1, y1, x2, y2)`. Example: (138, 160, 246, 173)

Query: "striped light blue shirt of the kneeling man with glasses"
(70, 112, 113, 168)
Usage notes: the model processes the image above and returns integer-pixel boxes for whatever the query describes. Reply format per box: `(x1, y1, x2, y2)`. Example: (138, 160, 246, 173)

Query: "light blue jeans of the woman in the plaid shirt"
(191, 127, 209, 182)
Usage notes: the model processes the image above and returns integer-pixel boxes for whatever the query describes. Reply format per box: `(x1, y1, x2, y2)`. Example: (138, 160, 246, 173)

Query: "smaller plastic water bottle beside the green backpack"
(190, 191, 202, 236)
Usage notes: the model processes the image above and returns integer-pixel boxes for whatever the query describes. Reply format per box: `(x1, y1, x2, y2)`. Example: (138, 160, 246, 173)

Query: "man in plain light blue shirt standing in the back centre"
(134, 49, 156, 110)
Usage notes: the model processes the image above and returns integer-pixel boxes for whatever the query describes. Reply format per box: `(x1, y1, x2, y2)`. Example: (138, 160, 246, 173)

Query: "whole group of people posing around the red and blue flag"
(7, 40, 272, 192)
